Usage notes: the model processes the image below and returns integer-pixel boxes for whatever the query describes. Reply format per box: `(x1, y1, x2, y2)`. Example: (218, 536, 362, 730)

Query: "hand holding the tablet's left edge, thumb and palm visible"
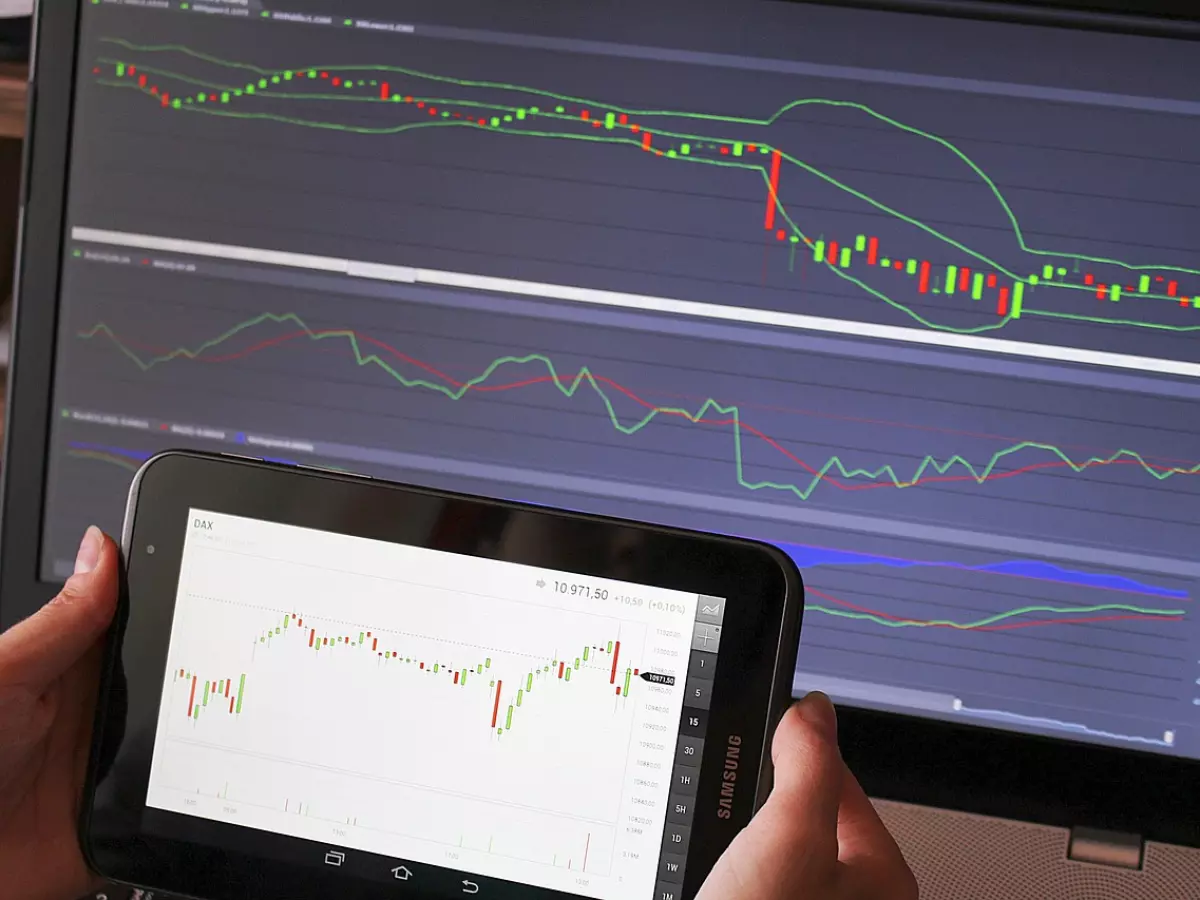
(0, 528, 118, 900)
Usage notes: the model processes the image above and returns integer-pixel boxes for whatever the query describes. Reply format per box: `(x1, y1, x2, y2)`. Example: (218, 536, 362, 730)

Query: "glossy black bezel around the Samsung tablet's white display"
(80, 451, 804, 900)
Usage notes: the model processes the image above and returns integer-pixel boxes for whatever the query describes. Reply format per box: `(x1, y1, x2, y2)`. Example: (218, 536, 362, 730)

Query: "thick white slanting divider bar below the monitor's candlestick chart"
(71, 228, 1200, 378)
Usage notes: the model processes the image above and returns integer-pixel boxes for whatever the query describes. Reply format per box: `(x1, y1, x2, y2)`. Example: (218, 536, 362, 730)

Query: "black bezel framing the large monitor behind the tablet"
(7, 0, 1200, 847)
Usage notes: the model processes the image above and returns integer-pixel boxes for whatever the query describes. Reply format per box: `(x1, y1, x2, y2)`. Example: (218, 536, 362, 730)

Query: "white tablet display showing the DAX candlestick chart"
(146, 509, 725, 900)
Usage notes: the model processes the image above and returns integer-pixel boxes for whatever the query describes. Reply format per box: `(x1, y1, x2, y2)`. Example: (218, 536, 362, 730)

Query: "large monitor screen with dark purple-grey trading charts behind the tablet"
(41, 0, 1200, 758)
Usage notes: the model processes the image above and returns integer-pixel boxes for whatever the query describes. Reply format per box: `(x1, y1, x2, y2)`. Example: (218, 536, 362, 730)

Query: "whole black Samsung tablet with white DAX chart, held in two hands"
(82, 452, 803, 900)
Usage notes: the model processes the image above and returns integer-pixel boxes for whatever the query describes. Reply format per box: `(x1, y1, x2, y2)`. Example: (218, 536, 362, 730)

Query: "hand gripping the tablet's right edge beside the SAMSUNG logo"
(696, 694, 917, 900)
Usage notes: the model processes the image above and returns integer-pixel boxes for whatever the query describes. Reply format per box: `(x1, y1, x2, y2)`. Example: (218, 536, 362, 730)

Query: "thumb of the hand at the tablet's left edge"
(0, 527, 120, 691)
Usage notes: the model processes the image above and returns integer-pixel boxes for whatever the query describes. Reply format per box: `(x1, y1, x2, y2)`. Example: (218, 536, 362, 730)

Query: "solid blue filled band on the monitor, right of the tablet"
(776, 544, 1190, 600)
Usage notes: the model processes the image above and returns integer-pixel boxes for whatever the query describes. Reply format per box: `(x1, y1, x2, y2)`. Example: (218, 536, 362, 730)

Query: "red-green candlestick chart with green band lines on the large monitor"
(84, 38, 1200, 359)
